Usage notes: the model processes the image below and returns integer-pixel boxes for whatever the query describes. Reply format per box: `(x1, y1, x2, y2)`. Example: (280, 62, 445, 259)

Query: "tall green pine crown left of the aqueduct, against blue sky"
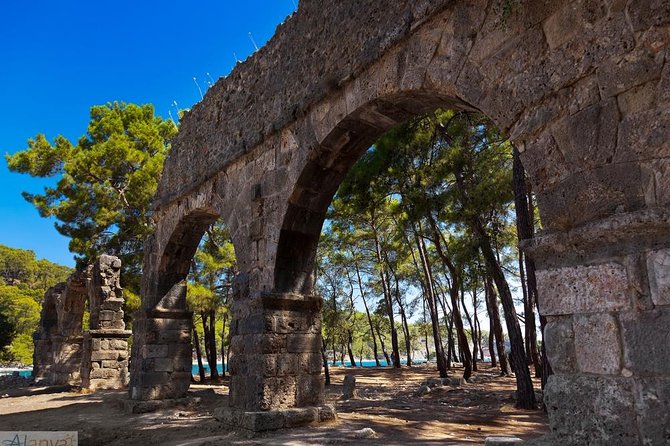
(6, 102, 177, 288)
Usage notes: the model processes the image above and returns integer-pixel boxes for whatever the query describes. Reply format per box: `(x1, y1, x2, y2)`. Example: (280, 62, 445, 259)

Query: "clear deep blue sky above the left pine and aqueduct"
(0, 0, 297, 265)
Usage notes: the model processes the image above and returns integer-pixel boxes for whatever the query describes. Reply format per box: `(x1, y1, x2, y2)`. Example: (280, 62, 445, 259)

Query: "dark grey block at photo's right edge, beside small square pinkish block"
(619, 307, 670, 376)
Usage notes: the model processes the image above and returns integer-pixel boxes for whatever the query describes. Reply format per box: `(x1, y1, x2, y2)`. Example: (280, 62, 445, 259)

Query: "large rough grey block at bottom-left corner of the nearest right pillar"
(544, 375, 639, 445)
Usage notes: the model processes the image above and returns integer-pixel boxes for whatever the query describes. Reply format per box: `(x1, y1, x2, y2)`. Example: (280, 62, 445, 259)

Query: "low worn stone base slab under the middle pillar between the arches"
(214, 405, 337, 432)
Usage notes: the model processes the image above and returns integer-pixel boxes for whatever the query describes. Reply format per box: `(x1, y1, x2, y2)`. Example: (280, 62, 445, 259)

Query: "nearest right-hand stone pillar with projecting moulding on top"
(525, 209, 670, 445)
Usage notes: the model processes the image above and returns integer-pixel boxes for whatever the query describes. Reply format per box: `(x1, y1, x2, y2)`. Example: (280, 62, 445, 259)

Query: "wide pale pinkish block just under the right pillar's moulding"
(537, 262, 631, 316)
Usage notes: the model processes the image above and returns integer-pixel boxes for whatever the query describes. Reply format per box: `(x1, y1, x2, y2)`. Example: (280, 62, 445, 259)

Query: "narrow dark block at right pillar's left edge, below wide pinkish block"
(544, 317, 577, 373)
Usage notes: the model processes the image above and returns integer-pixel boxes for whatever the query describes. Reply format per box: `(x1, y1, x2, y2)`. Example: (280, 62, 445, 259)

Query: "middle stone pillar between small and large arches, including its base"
(215, 293, 335, 431)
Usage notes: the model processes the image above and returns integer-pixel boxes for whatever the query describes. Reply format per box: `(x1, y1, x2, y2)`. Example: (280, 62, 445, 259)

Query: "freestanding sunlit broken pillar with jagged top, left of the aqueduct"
(81, 255, 131, 389)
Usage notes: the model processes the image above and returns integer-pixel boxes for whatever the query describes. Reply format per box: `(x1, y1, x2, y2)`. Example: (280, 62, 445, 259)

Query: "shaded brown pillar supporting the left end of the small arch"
(130, 309, 193, 400)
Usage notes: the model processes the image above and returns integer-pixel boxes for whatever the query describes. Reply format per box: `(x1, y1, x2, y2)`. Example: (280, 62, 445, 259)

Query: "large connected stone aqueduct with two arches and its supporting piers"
(124, 0, 670, 444)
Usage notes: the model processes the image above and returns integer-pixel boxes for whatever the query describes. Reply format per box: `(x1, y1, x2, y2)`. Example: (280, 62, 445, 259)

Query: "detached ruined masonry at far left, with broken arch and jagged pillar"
(33, 255, 131, 389)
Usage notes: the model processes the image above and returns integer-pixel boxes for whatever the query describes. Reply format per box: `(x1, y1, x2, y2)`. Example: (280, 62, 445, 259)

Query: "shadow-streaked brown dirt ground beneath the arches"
(0, 365, 548, 446)
